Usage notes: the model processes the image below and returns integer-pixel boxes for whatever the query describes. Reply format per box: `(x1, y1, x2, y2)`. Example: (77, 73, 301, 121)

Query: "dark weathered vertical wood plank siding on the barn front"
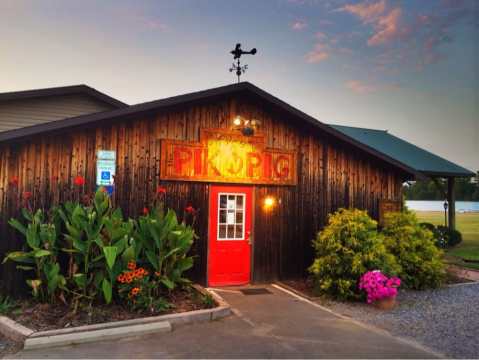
(0, 93, 404, 288)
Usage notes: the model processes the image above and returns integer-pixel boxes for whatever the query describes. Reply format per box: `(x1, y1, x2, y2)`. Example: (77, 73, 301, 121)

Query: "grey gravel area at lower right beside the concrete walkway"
(321, 283, 479, 358)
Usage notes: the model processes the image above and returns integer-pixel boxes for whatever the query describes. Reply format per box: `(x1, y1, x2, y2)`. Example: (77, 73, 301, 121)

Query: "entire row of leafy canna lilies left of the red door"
(3, 181, 196, 312)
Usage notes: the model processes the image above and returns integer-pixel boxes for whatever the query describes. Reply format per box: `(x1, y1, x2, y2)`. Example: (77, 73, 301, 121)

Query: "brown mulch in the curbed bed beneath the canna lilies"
(9, 289, 212, 331)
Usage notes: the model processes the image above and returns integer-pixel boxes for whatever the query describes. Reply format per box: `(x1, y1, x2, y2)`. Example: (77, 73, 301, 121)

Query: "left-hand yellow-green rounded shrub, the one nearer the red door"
(309, 209, 400, 300)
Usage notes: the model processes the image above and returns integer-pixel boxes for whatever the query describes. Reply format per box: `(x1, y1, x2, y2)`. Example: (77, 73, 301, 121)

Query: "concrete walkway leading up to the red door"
(11, 286, 434, 358)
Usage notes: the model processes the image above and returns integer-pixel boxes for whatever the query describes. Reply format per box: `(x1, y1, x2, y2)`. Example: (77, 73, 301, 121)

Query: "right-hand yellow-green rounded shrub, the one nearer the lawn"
(383, 212, 445, 290)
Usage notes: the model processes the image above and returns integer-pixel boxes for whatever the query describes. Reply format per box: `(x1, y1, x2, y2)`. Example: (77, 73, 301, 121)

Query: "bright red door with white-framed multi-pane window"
(208, 185, 253, 286)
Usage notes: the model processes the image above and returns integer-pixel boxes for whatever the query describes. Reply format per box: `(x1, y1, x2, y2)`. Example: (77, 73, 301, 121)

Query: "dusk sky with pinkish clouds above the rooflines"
(0, 0, 479, 170)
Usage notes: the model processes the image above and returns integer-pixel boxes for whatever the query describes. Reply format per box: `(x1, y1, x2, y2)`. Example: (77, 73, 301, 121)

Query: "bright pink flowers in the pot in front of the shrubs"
(359, 270, 401, 303)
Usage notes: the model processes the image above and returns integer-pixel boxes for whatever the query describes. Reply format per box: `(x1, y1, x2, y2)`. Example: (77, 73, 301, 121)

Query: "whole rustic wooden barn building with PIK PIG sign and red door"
(0, 82, 473, 287)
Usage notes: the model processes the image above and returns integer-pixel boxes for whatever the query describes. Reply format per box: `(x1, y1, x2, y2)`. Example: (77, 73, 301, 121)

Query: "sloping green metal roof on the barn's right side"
(330, 125, 475, 177)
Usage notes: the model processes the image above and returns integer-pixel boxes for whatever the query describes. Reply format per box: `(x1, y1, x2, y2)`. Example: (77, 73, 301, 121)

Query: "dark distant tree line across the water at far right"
(403, 173, 479, 201)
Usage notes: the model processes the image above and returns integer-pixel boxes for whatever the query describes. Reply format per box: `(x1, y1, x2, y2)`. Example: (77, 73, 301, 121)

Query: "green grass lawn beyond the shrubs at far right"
(416, 211, 479, 270)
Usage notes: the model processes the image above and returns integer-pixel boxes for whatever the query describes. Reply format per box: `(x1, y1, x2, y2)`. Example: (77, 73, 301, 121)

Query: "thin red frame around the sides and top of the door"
(205, 183, 256, 286)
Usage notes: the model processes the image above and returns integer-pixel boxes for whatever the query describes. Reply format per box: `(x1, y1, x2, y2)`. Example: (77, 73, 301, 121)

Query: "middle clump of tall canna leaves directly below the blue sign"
(60, 190, 133, 304)
